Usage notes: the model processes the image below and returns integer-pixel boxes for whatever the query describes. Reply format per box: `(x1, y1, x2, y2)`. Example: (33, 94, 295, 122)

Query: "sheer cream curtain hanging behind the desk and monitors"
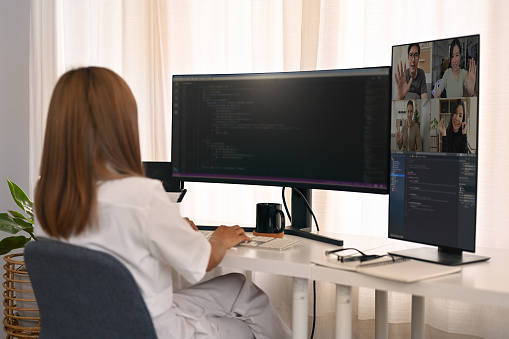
(30, 0, 509, 338)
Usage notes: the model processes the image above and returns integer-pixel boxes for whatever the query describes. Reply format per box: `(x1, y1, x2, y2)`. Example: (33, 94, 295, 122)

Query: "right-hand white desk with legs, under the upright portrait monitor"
(311, 250, 509, 339)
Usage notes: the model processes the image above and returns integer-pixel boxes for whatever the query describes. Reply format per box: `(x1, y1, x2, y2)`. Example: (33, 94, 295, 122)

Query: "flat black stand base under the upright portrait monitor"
(389, 247, 490, 266)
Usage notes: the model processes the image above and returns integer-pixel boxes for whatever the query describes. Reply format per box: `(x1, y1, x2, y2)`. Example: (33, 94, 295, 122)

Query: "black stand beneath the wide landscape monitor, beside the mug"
(285, 188, 343, 246)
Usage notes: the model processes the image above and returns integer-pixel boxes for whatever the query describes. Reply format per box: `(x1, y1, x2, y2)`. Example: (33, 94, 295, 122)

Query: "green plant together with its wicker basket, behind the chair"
(0, 179, 40, 337)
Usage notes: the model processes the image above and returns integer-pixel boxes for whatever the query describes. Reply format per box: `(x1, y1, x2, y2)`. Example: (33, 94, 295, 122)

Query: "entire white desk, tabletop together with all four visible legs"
(220, 235, 509, 338)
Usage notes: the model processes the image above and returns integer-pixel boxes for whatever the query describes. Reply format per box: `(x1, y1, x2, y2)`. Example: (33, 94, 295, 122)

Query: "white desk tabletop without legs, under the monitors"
(220, 235, 509, 307)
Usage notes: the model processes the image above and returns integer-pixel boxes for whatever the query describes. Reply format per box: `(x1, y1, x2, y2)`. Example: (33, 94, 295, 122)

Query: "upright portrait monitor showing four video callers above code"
(389, 35, 488, 264)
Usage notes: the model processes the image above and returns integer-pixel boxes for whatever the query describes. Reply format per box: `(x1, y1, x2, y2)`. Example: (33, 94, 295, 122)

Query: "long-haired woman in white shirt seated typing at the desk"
(35, 67, 291, 339)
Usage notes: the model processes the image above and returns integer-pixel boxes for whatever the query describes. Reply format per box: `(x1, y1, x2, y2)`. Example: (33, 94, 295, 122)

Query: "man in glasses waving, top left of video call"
(394, 44, 428, 100)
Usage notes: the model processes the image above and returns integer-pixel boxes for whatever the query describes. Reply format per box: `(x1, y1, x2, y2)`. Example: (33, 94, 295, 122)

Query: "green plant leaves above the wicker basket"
(0, 179, 37, 255)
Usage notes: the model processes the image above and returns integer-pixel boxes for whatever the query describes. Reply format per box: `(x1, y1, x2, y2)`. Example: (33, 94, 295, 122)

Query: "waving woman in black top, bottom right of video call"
(438, 99, 468, 153)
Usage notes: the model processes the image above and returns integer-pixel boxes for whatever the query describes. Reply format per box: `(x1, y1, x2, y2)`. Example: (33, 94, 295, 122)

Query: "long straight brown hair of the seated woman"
(35, 67, 144, 239)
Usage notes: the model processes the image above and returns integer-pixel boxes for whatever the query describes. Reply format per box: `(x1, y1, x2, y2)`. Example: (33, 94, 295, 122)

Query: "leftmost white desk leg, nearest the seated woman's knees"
(292, 278, 309, 339)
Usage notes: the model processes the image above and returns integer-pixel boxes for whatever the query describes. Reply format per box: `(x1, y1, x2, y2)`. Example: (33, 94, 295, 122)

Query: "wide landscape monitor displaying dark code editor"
(172, 67, 391, 193)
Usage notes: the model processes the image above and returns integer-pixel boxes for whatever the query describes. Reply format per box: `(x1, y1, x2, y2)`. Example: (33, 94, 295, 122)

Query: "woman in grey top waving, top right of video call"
(435, 39, 477, 99)
